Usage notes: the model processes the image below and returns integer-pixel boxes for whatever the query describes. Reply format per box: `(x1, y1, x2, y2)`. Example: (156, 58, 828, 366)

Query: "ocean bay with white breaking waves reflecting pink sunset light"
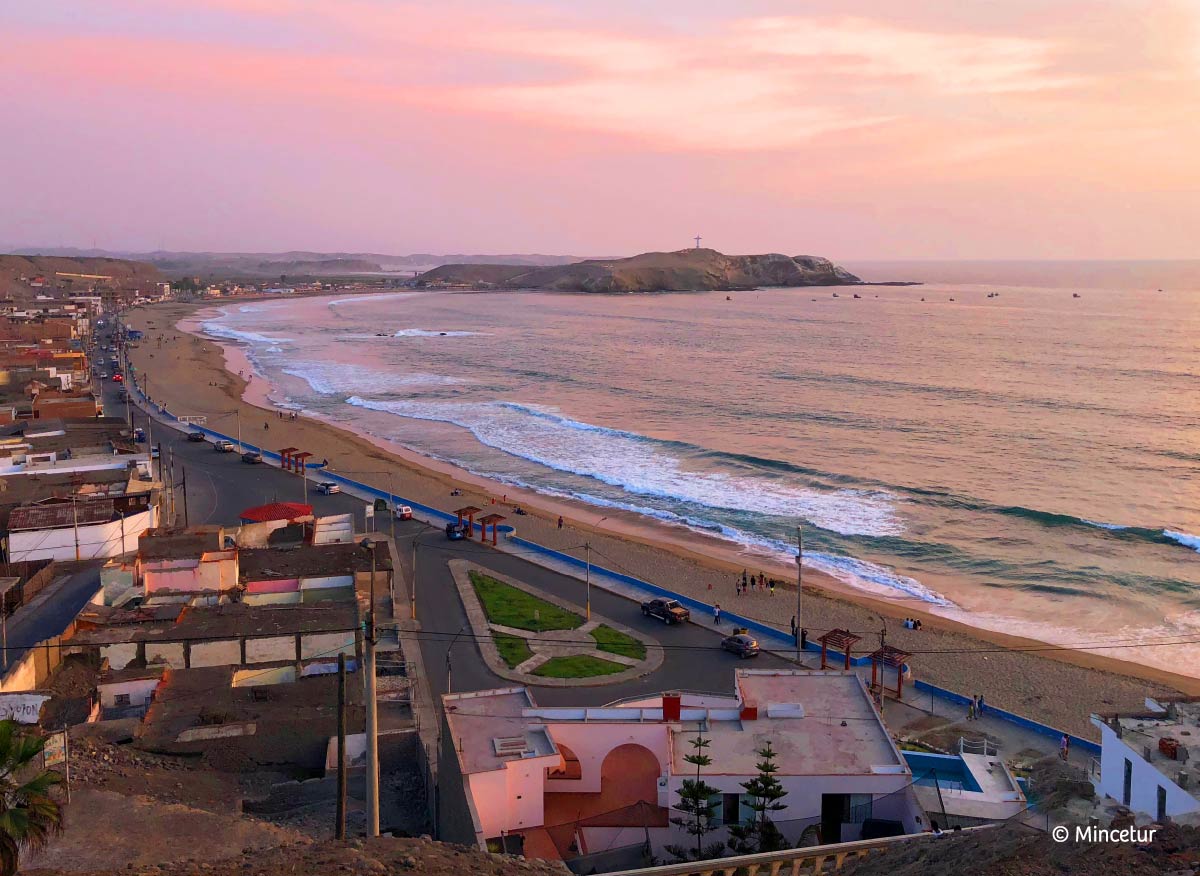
(204, 263, 1200, 674)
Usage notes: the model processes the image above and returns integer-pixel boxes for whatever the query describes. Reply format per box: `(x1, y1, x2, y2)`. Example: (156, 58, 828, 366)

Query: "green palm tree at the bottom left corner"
(0, 718, 62, 876)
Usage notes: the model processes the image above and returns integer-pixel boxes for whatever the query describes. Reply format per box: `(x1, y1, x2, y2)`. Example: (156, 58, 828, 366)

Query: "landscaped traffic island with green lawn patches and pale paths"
(450, 559, 662, 686)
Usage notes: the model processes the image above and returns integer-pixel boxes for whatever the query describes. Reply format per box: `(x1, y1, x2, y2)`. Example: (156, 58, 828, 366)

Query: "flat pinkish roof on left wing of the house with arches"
(442, 688, 558, 775)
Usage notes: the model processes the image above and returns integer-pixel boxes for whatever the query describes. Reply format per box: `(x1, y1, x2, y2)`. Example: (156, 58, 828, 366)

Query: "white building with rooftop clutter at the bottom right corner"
(1091, 700, 1200, 821)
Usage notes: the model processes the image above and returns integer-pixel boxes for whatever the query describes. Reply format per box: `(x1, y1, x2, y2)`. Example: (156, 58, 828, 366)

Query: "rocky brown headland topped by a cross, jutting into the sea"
(416, 248, 863, 293)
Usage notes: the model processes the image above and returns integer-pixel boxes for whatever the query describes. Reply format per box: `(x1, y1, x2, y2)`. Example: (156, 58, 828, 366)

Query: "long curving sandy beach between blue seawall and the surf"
(125, 304, 1200, 738)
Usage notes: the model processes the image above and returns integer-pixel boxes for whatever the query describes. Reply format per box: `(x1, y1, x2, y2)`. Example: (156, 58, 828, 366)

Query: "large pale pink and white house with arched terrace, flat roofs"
(439, 670, 926, 869)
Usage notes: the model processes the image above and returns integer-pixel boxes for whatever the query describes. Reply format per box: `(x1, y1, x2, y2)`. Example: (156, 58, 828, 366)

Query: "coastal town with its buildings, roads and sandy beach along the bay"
(0, 257, 1200, 876)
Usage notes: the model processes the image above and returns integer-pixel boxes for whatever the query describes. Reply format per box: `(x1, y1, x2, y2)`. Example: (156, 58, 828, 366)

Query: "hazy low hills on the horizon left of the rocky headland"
(11, 247, 580, 280)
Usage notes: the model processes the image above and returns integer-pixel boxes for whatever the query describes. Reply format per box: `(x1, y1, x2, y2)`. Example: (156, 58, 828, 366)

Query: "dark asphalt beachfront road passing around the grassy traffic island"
(104, 380, 790, 706)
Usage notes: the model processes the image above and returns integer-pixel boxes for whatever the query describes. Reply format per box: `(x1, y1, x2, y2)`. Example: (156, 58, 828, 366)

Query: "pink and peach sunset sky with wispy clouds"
(0, 0, 1200, 259)
